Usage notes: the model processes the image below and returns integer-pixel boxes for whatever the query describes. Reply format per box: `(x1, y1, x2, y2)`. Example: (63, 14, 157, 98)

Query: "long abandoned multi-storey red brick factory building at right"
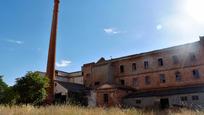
(82, 37, 204, 108)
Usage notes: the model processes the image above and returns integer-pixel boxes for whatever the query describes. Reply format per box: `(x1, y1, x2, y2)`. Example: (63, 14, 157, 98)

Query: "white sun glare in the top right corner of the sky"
(186, 0, 204, 24)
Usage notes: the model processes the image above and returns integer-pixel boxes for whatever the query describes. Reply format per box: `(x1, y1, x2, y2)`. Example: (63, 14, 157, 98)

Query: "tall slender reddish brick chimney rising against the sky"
(46, 0, 59, 104)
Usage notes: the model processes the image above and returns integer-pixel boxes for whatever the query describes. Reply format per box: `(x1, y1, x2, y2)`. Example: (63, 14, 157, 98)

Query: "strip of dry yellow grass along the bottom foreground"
(0, 105, 204, 115)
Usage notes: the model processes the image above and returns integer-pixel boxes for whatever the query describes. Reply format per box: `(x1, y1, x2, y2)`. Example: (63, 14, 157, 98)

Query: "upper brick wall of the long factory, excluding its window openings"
(82, 38, 204, 90)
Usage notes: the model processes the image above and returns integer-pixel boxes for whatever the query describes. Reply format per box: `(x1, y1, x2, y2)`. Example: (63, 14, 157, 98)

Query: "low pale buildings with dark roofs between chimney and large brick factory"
(38, 70, 84, 105)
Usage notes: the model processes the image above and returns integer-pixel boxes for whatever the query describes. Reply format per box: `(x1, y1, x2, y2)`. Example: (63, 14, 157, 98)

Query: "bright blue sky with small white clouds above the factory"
(0, 0, 204, 85)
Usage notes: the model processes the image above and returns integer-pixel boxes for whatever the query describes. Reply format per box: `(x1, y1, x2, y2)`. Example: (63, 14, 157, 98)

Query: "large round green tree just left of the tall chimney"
(14, 72, 49, 105)
